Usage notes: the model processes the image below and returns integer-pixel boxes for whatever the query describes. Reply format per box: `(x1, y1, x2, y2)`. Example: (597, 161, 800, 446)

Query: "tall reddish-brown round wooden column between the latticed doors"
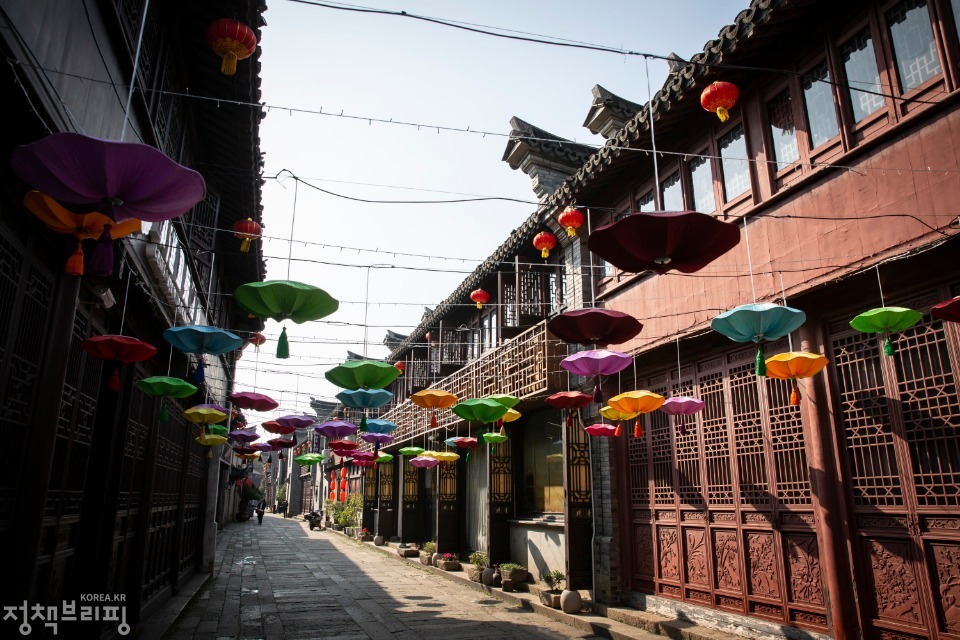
(800, 320, 861, 640)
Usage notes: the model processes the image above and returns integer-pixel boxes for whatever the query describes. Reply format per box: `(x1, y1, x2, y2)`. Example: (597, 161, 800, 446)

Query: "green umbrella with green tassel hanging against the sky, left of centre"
(233, 280, 340, 358)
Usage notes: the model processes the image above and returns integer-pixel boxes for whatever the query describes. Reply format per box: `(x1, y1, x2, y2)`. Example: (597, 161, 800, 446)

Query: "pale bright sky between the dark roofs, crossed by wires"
(235, 0, 748, 424)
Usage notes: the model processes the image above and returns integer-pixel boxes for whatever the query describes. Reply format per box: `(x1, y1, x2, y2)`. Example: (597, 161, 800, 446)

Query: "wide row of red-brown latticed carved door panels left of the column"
(629, 344, 827, 631)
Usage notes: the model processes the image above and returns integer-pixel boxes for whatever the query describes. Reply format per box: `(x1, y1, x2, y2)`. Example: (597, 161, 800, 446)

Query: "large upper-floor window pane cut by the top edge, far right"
(887, 0, 940, 92)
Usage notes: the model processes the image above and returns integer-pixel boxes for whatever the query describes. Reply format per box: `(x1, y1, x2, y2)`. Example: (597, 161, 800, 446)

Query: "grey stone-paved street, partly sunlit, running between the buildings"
(166, 513, 594, 640)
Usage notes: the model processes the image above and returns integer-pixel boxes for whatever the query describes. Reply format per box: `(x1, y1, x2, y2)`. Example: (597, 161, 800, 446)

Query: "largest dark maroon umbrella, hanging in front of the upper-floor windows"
(587, 211, 740, 274)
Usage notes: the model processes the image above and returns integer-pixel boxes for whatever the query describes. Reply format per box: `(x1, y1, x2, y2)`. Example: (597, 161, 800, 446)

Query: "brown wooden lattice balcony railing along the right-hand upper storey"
(380, 322, 567, 442)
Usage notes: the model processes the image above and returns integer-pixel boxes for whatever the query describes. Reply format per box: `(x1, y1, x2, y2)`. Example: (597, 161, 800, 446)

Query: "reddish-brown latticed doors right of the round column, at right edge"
(831, 291, 960, 640)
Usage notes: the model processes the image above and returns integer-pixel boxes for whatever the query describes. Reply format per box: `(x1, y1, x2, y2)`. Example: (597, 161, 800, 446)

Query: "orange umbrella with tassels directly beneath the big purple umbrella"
(23, 191, 142, 276)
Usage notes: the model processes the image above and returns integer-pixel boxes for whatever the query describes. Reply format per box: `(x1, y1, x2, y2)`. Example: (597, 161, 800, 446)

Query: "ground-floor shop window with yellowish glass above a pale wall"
(523, 414, 563, 515)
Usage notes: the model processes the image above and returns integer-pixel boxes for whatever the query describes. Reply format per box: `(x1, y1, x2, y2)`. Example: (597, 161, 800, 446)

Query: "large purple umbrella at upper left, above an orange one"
(11, 132, 206, 222)
